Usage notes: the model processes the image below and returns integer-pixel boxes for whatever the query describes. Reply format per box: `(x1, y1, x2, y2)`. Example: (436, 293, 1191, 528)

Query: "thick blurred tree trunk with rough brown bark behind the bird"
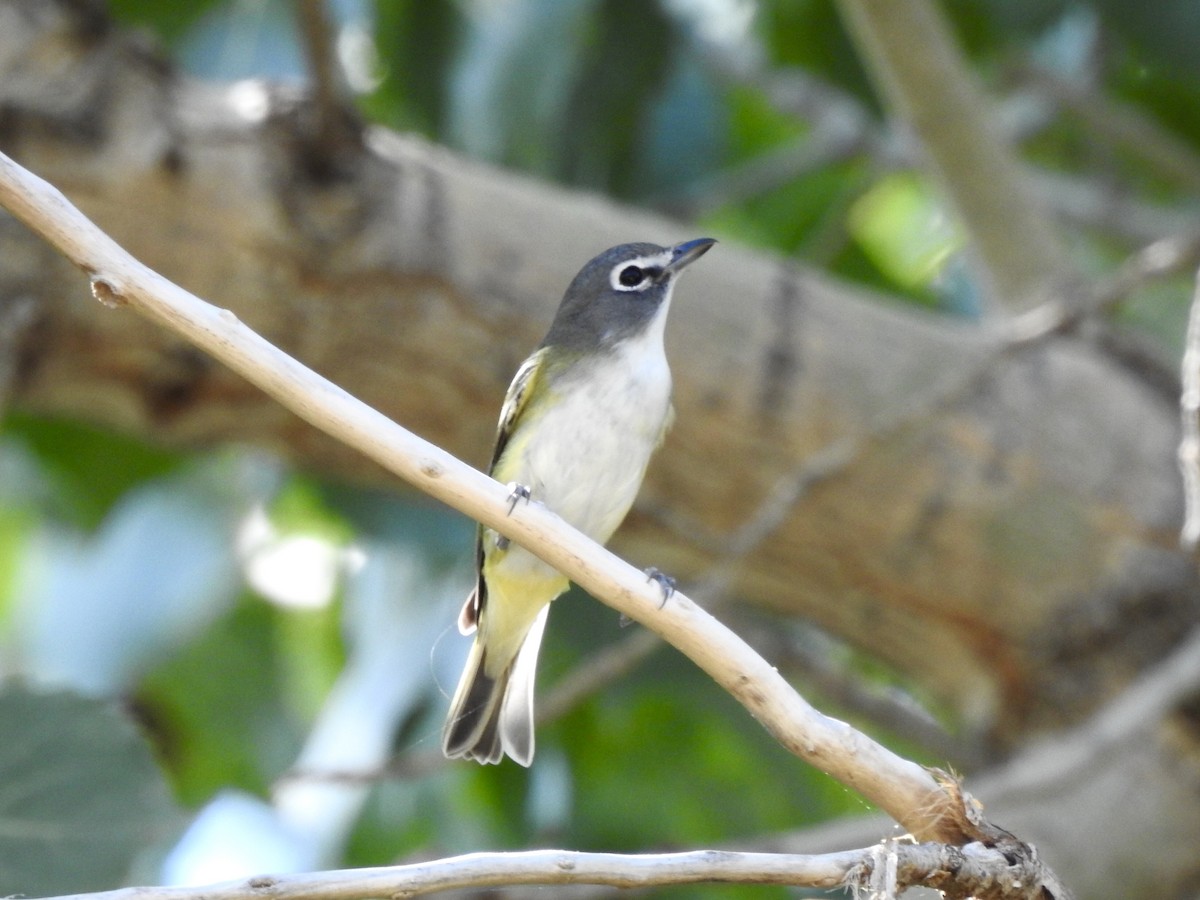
(0, 2, 1200, 895)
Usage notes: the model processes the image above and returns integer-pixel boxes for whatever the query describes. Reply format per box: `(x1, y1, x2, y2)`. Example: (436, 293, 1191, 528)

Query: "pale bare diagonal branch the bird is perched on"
(0, 155, 980, 842)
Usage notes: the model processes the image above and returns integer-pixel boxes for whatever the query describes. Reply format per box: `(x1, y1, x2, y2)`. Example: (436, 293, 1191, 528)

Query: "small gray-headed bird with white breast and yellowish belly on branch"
(442, 238, 716, 767)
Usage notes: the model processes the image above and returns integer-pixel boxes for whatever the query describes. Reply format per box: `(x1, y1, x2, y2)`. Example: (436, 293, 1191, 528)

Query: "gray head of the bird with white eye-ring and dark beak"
(542, 238, 716, 353)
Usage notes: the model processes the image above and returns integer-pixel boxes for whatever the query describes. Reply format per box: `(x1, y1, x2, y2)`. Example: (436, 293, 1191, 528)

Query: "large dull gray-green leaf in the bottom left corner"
(0, 685, 182, 896)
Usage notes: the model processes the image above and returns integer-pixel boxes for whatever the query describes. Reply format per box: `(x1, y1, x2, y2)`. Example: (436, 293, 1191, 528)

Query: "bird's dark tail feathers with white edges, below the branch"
(442, 604, 550, 766)
